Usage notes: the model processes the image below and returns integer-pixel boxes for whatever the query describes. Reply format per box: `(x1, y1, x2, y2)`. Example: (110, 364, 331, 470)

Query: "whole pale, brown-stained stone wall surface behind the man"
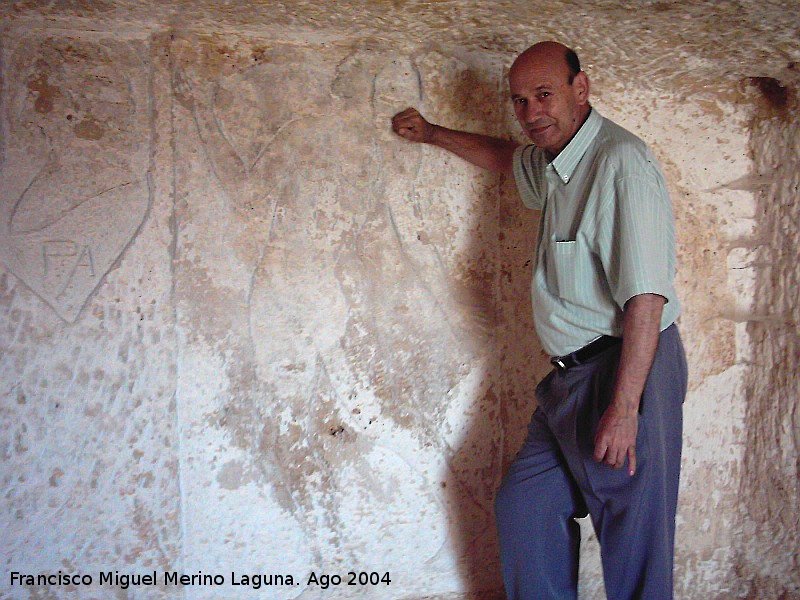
(0, 0, 800, 600)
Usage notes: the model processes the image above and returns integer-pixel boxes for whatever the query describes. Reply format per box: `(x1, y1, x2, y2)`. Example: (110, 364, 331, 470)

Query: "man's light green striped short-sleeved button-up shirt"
(514, 109, 680, 356)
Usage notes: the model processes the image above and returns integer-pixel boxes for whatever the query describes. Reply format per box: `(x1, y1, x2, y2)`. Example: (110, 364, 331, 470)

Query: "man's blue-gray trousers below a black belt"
(495, 325, 687, 600)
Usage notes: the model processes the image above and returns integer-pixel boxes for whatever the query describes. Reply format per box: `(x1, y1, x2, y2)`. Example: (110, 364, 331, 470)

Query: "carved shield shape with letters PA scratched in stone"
(0, 37, 151, 322)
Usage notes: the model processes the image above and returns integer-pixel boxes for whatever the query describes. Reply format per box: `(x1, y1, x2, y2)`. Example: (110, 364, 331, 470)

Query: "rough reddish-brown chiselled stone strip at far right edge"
(737, 69, 800, 598)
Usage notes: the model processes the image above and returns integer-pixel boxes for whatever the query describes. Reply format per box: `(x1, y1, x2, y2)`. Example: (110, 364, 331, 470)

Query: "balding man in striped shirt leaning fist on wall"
(392, 42, 687, 600)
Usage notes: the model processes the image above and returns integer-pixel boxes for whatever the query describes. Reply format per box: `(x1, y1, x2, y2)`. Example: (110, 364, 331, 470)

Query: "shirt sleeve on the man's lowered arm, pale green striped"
(600, 176, 676, 309)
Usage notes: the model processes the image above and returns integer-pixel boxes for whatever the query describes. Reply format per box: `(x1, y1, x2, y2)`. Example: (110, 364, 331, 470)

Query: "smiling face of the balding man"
(509, 53, 589, 158)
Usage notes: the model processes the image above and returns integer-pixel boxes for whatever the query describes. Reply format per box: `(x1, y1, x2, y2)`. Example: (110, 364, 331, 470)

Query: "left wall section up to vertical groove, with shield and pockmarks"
(0, 31, 182, 598)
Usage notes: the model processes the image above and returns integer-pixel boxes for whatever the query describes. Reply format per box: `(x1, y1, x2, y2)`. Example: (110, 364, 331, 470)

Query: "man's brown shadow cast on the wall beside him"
(430, 61, 549, 600)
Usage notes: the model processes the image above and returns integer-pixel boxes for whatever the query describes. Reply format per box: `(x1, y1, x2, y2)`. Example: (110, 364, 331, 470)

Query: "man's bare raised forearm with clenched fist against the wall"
(392, 108, 519, 175)
